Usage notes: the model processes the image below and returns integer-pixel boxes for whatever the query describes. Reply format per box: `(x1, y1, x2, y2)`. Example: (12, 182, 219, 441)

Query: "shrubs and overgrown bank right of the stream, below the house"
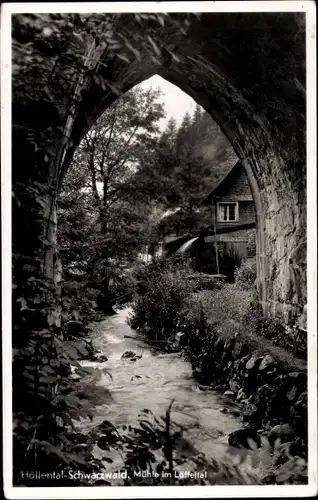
(130, 259, 308, 484)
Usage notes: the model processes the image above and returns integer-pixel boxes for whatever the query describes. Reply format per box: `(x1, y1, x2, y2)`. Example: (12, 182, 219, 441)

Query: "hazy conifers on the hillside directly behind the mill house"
(142, 106, 236, 236)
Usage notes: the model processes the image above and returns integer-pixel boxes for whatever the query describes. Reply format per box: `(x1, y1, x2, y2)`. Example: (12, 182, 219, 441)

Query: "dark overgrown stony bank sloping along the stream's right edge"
(170, 308, 308, 464)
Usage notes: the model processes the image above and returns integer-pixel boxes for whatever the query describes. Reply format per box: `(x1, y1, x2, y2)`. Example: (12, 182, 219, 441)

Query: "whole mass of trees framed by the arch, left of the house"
(58, 87, 237, 312)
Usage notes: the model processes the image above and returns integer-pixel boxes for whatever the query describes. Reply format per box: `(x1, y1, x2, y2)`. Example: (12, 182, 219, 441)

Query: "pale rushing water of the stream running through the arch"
(76, 308, 240, 482)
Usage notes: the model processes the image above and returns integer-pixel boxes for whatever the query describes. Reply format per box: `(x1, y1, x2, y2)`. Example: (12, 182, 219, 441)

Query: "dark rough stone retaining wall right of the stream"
(190, 331, 308, 456)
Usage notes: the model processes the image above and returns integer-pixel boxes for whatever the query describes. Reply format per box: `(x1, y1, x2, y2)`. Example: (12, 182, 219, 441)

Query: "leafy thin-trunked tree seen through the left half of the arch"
(58, 83, 164, 312)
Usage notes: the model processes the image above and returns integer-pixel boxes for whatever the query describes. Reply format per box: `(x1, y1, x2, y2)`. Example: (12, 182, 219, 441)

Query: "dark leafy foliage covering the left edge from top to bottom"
(12, 14, 199, 485)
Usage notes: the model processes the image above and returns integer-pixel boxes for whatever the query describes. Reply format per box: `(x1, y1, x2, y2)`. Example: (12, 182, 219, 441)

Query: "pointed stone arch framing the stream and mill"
(12, 13, 306, 322)
